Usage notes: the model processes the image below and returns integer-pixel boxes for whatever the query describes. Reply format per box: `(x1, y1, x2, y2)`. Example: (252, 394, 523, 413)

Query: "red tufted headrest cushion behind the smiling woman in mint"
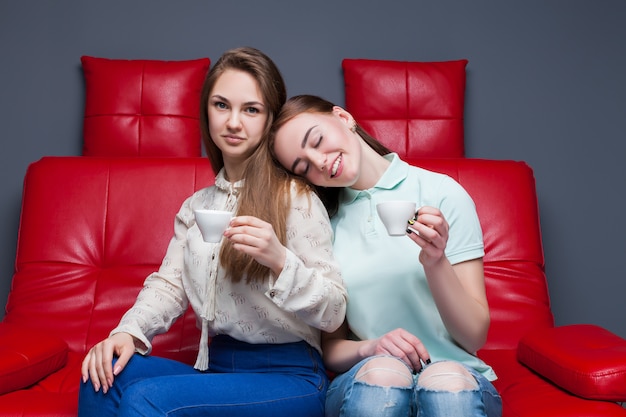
(342, 59, 467, 158)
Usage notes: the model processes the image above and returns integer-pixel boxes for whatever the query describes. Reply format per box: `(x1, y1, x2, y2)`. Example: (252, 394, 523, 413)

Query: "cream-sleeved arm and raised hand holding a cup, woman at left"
(225, 190, 347, 331)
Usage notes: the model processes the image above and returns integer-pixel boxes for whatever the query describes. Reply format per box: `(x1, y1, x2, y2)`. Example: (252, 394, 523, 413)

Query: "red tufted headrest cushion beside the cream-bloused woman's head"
(81, 56, 210, 157)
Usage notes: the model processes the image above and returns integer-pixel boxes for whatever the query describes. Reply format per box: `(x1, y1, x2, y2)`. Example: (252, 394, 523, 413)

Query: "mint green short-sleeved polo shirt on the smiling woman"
(331, 153, 496, 380)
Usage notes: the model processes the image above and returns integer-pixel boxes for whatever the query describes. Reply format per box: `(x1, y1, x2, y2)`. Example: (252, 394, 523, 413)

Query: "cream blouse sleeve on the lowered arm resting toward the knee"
(110, 199, 190, 354)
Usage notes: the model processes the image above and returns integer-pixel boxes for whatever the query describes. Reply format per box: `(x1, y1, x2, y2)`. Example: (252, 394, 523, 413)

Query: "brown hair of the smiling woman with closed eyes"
(268, 94, 392, 217)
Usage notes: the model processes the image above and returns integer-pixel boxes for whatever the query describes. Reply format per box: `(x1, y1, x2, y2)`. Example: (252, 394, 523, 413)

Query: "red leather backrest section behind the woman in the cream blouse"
(5, 157, 214, 361)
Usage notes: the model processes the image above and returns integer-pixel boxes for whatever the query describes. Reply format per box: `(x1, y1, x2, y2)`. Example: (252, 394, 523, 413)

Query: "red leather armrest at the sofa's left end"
(0, 323, 68, 395)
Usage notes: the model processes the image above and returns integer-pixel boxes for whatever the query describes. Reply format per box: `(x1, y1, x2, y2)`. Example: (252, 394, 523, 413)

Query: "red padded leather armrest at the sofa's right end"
(517, 324, 626, 402)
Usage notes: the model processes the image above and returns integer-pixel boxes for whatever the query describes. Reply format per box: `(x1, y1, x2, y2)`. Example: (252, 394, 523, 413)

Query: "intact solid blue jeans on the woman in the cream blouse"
(78, 336, 328, 417)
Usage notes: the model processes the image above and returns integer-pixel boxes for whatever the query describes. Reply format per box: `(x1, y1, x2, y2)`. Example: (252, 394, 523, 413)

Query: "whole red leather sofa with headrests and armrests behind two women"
(0, 57, 626, 417)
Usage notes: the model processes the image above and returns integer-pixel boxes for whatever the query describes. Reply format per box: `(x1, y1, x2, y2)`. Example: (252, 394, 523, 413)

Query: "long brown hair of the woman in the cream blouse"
(200, 47, 306, 281)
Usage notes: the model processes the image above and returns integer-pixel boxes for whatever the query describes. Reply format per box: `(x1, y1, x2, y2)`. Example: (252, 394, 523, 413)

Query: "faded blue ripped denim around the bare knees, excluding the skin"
(326, 358, 502, 417)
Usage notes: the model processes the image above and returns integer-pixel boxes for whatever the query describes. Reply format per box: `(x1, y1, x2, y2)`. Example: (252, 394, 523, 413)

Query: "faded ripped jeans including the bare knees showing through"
(326, 356, 502, 417)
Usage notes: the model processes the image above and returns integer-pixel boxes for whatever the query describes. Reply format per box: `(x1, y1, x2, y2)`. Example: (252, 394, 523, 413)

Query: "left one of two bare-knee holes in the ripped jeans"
(355, 357, 413, 387)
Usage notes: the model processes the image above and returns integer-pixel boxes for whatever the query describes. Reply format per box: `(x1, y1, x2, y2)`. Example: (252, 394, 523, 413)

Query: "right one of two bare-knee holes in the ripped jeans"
(417, 361, 478, 392)
